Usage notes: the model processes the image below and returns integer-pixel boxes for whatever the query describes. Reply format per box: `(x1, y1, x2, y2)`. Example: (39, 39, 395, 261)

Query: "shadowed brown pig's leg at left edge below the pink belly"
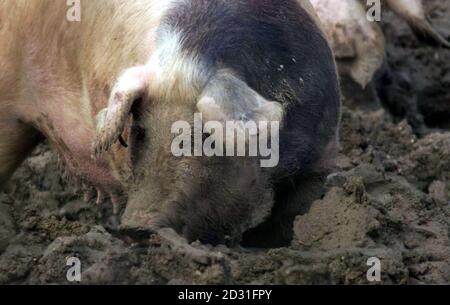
(0, 117, 41, 188)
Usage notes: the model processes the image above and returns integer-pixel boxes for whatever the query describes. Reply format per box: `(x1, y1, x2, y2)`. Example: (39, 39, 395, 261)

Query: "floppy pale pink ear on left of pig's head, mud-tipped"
(92, 67, 148, 157)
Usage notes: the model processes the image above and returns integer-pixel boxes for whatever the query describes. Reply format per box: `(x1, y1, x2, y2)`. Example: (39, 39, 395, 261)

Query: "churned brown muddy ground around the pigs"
(0, 0, 450, 284)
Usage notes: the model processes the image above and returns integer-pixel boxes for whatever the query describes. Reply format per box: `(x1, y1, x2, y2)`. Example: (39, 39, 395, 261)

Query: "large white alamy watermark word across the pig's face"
(171, 113, 280, 167)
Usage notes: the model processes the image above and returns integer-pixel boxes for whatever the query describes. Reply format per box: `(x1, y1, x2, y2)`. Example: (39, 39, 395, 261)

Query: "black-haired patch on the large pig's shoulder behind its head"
(163, 0, 340, 245)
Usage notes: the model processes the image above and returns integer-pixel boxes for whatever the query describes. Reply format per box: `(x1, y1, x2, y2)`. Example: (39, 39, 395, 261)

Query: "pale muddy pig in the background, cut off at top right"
(311, 0, 450, 89)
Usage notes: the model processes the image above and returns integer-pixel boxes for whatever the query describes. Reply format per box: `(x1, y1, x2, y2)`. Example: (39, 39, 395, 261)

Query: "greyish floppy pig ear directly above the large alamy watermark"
(197, 72, 283, 127)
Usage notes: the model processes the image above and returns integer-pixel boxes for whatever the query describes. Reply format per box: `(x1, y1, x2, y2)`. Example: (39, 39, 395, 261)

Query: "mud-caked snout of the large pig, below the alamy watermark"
(121, 159, 273, 246)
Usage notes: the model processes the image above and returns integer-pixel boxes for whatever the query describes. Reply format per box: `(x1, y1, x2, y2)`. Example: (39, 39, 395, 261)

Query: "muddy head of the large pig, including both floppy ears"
(94, 66, 283, 244)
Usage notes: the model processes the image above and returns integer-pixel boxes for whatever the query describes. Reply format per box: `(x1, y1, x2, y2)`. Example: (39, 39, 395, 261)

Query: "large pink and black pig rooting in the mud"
(0, 0, 340, 245)
